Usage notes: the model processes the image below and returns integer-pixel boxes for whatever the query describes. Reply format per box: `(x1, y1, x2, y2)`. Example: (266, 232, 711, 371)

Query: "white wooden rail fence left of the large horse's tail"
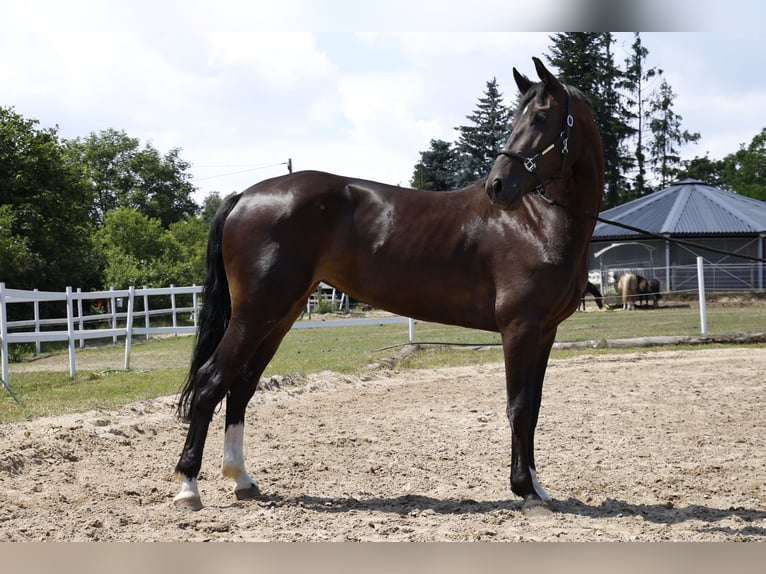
(0, 283, 202, 391)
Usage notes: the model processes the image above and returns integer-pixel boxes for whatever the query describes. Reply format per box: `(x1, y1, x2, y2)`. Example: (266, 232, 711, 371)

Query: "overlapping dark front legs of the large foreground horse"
(503, 321, 555, 511)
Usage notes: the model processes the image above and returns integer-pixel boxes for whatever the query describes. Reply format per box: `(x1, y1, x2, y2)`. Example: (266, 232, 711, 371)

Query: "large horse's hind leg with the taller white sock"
(221, 317, 294, 500)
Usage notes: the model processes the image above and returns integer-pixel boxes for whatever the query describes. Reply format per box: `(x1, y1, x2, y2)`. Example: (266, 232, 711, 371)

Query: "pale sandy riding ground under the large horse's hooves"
(0, 347, 766, 541)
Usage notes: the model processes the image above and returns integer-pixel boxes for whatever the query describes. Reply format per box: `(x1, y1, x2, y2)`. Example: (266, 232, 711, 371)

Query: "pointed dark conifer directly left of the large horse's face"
(454, 78, 513, 187)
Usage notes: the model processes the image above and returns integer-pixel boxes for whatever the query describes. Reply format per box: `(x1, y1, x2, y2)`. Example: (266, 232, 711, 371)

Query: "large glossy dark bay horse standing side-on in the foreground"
(175, 58, 604, 509)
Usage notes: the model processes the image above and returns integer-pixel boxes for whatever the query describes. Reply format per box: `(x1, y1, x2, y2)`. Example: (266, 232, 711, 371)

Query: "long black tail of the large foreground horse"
(178, 193, 242, 421)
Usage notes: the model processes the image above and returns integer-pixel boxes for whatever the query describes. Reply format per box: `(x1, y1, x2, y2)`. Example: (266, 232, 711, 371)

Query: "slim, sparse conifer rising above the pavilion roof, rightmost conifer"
(649, 80, 700, 187)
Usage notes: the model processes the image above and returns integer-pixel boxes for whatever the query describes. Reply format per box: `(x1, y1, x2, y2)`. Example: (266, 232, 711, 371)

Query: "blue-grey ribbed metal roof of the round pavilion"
(593, 179, 766, 241)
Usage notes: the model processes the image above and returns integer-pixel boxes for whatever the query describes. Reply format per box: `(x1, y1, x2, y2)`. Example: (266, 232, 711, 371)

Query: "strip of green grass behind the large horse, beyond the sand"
(0, 304, 766, 423)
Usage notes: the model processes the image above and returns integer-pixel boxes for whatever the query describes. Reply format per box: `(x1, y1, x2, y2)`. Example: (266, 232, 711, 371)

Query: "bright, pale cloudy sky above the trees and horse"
(0, 0, 766, 202)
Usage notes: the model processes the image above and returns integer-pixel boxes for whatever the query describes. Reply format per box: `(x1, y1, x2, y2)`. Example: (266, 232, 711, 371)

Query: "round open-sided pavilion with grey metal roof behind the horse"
(590, 179, 766, 291)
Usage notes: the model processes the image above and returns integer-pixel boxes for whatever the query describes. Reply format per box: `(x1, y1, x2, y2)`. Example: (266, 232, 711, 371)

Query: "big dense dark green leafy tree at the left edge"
(0, 108, 98, 290)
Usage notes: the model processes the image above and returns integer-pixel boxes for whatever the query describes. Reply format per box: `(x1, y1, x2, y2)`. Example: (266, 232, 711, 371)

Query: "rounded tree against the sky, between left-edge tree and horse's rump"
(69, 129, 198, 228)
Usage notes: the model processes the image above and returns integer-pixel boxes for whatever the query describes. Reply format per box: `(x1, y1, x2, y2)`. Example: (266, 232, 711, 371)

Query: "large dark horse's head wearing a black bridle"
(485, 58, 600, 209)
